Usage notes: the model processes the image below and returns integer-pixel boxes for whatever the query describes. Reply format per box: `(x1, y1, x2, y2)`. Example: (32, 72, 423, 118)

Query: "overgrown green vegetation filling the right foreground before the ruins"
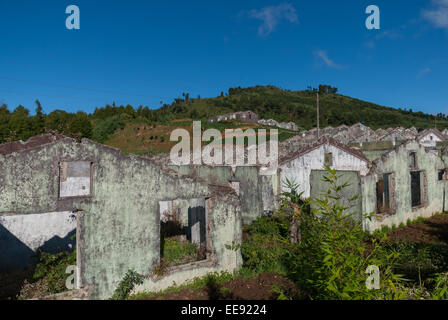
(131, 168, 448, 300)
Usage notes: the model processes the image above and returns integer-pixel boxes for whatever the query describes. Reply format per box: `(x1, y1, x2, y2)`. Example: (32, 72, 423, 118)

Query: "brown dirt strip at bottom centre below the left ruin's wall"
(135, 273, 297, 300)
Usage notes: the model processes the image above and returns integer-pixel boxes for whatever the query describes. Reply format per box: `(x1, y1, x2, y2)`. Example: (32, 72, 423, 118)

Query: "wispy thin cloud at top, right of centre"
(249, 3, 299, 36)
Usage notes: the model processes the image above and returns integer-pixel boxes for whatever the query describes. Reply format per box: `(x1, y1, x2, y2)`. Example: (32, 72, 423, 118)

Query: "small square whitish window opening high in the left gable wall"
(59, 161, 92, 198)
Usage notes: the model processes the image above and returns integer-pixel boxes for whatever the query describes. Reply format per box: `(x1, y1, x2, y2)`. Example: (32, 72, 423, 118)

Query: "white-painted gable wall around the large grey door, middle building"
(280, 144, 369, 198)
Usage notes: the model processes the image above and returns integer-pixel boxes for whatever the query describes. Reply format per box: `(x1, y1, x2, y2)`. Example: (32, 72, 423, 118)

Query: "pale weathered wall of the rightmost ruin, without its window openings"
(362, 141, 447, 231)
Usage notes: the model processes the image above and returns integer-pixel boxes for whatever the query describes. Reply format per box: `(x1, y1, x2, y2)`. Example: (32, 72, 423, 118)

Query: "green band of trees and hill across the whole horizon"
(0, 85, 448, 143)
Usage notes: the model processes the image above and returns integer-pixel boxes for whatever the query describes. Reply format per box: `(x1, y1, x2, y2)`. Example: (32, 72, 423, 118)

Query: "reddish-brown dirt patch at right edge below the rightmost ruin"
(388, 214, 448, 245)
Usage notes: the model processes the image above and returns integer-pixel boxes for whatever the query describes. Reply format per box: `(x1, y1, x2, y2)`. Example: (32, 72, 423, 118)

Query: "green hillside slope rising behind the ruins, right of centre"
(156, 86, 448, 129)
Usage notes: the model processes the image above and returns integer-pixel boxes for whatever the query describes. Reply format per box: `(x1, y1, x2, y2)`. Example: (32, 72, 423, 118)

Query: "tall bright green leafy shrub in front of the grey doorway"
(284, 167, 406, 300)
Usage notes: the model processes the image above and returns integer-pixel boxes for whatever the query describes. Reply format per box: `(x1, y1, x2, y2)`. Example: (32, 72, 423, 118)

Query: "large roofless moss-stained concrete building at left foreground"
(0, 137, 242, 299)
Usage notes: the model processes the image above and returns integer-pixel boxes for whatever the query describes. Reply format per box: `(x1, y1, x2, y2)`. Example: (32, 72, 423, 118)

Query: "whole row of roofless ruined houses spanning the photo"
(0, 125, 448, 299)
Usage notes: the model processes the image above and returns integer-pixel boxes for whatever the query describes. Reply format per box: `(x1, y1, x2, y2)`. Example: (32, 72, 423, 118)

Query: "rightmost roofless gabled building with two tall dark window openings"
(360, 140, 448, 231)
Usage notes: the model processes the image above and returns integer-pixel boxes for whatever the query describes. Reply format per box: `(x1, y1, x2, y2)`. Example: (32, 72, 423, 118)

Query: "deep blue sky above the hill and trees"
(0, 0, 448, 113)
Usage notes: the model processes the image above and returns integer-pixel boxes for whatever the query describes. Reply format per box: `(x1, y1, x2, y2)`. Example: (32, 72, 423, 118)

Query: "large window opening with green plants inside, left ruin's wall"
(159, 199, 207, 267)
